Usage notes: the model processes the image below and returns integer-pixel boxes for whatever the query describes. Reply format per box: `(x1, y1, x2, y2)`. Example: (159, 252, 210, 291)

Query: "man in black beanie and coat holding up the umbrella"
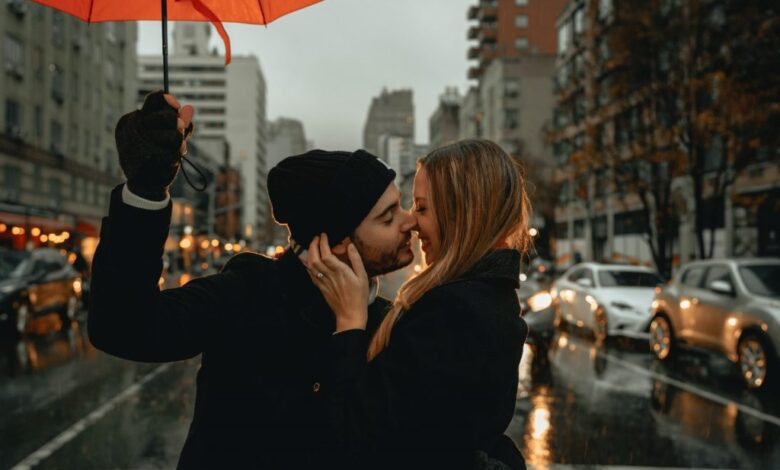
(89, 92, 415, 469)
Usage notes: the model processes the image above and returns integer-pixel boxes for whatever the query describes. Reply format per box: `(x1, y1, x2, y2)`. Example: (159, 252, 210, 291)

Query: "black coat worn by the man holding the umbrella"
(88, 186, 389, 469)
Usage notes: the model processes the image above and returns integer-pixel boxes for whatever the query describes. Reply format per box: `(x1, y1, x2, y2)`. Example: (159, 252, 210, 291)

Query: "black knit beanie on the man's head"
(268, 150, 395, 248)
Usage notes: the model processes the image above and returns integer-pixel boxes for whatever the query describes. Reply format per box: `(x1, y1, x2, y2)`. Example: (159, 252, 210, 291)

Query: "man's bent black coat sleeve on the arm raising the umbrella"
(88, 186, 243, 362)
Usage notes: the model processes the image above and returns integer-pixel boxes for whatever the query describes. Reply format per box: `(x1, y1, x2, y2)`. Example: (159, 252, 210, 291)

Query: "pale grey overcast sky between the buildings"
(138, 0, 476, 149)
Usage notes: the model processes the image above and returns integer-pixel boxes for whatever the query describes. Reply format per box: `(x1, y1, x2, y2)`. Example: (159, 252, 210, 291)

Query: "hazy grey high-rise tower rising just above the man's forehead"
(363, 89, 414, 155)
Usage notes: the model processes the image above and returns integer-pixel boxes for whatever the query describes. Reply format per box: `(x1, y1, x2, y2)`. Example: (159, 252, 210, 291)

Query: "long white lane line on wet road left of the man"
(11, 364, 171, 470)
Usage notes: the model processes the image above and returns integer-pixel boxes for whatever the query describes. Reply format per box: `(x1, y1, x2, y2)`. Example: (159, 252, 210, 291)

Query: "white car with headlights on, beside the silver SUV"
(550, 263, 664, 342)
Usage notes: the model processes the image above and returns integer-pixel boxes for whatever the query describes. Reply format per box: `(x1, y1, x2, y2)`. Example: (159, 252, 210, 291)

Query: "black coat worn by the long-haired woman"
(326, 250, 528, 468)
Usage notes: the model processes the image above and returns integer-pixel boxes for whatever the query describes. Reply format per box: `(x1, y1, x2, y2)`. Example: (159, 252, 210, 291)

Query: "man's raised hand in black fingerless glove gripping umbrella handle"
(115, 91, 195, 201)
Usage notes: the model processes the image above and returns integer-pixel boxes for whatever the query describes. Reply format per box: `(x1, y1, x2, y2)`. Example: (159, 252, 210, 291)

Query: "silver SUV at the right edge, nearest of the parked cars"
(650, 258, 780, 388)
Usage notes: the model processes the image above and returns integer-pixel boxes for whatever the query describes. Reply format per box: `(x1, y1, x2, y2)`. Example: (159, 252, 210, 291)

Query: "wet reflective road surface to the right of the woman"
(507, 332, 780, 468)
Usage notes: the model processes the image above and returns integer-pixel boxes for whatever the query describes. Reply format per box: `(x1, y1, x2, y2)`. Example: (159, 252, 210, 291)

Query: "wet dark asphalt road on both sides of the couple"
(0, 310, 780, 470)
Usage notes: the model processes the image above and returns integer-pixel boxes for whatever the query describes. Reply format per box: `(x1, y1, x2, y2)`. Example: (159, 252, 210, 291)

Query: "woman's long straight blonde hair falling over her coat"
(368, 140, 531, 360)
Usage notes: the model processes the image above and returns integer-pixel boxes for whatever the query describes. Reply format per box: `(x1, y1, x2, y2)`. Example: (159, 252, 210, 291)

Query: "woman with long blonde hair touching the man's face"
(308, 140, 530, 468)
